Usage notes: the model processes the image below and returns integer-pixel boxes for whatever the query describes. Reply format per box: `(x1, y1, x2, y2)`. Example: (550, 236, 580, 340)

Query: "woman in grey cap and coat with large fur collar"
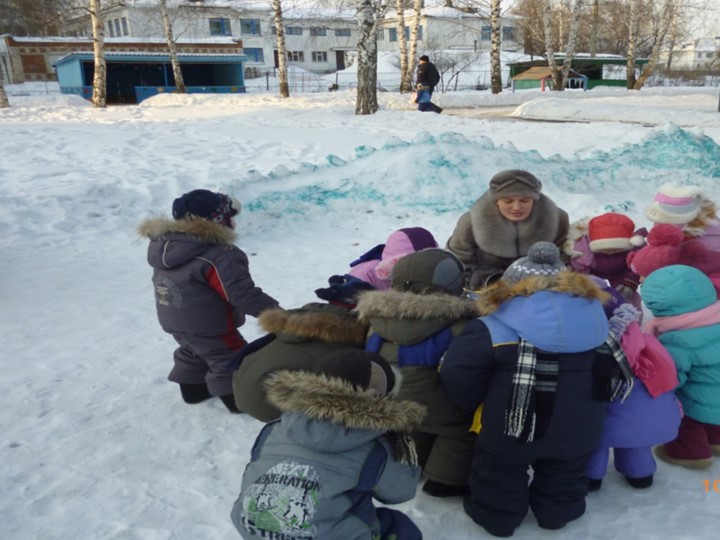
(446, 170, 569, 290)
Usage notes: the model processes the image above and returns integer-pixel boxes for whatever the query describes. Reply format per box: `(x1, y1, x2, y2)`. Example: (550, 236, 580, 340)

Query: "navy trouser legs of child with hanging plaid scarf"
(465, 447, 590, 536)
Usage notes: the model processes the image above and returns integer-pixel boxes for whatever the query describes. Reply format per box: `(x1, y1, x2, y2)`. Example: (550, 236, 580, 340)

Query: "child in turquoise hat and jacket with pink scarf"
(642, 264, 720, 469)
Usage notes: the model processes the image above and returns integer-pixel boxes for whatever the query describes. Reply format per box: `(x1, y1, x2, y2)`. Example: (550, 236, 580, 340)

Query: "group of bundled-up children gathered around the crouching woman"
(140, 185, 720, 540)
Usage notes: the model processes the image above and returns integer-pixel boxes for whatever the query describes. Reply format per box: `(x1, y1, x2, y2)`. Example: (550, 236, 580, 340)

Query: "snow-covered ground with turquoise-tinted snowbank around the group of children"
(0, 82, 720, 540)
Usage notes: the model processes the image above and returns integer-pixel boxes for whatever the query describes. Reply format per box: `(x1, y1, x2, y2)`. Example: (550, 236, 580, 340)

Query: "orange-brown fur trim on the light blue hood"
(476, 270, 610, 315)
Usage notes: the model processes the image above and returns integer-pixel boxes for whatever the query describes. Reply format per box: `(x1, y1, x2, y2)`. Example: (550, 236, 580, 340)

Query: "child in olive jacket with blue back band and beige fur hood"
(356, 249, 477, 497)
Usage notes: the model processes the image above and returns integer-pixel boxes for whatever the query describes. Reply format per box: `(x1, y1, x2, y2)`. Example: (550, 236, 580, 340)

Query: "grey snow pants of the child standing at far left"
(168, 331, 246, 396)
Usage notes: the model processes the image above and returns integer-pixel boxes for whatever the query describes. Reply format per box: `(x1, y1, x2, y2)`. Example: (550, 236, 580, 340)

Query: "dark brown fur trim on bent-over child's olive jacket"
(258, 302, 368, 346)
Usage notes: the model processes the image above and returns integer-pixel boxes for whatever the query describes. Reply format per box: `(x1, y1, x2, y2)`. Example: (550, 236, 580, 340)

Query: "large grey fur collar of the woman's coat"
(470, 192, 569, 259)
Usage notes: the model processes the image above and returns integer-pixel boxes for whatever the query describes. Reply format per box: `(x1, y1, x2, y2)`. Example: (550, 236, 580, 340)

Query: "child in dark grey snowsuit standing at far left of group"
(138, 189, 278, 412)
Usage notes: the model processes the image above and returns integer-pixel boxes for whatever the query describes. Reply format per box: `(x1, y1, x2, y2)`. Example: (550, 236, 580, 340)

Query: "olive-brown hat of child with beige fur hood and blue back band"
(391, 249, 464, 296)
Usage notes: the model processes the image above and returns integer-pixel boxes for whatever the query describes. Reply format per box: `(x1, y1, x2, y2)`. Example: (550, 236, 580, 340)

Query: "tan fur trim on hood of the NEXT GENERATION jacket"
(265, 370, 426, 433)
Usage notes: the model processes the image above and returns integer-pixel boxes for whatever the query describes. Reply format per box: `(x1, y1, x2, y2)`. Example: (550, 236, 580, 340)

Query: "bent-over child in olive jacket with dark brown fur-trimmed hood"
(233, 302, 368, 422)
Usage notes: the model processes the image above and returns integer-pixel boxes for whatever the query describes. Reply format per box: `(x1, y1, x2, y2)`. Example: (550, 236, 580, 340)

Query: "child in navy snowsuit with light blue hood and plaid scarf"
(440, 242, 629, 536)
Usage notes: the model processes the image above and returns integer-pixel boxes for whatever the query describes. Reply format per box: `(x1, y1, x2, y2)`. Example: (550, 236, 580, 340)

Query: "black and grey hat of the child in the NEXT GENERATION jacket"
(315, 349, 397, 396)
